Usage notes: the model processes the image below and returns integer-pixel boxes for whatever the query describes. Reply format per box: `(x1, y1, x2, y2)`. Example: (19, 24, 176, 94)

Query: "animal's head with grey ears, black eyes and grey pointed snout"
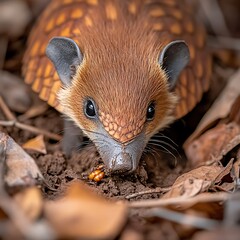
(47, 37, 189, 172)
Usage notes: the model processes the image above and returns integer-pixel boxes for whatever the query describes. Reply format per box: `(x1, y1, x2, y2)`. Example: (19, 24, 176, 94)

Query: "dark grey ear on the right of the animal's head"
(159, 40, 190, 89)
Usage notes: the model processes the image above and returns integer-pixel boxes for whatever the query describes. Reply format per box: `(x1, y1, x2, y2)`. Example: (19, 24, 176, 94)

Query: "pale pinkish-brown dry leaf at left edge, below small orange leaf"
(0, 132, 43, 187)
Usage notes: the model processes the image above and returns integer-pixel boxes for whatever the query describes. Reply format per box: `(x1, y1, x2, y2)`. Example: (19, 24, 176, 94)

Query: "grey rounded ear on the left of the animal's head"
(46, 37, 83, 86)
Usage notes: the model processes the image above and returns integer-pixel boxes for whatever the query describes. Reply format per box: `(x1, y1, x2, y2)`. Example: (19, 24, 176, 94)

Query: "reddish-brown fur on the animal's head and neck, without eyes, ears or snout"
(59, 1, 176, 140)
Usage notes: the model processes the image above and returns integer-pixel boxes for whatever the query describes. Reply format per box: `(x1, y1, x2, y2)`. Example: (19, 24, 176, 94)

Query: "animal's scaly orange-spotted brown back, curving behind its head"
(23, 0, 211, 118)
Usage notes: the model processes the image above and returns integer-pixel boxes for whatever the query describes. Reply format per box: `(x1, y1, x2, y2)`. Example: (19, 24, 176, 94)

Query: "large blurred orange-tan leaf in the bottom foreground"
(44, 182, 128, 239)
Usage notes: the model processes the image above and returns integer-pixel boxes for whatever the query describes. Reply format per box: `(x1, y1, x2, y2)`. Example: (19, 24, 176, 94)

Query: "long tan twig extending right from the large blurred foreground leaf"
(128, 192, 230, 208)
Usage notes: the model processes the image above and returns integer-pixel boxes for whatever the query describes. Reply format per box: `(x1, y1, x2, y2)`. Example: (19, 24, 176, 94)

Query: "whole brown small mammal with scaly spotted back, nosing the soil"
(23, 0, 211, 173)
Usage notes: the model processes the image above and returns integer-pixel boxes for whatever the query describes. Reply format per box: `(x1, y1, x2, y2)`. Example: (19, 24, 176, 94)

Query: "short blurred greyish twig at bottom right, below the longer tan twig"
(147, 208, 221, 230)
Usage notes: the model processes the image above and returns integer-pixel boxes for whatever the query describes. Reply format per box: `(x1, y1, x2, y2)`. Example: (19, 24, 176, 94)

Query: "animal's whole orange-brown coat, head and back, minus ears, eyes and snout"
(23, 0, 210, 143)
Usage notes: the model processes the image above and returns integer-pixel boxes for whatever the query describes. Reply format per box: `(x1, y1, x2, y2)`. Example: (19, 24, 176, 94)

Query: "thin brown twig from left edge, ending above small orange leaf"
(0, 121, 62, 141)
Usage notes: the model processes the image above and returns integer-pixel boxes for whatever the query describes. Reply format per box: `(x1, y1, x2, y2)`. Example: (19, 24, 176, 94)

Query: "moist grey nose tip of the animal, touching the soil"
(111, 153, 133, 173)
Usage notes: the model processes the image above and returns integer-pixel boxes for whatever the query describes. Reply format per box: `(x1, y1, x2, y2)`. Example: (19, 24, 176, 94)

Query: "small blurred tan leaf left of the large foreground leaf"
(14, 187, 43, 221)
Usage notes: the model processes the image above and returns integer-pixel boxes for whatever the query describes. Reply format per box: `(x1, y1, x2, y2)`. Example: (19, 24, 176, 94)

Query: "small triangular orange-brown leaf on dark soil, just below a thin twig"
(22, 135, 47, 154)
